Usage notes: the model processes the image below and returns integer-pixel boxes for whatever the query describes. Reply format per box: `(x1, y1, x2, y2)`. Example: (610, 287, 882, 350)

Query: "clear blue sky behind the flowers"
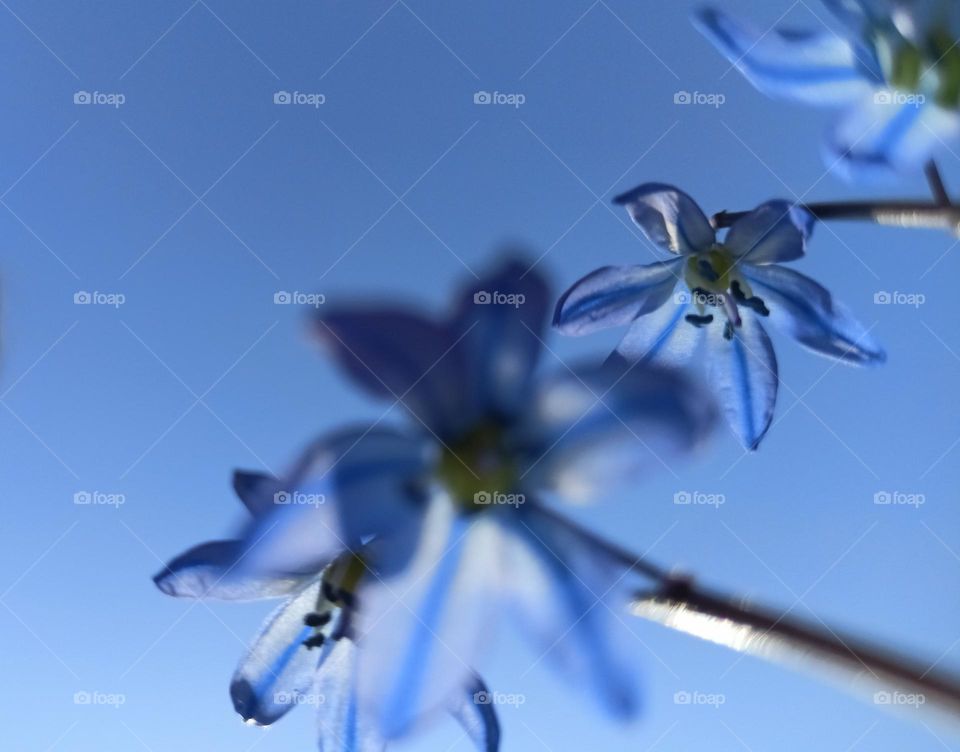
(0, 0, 960, 752)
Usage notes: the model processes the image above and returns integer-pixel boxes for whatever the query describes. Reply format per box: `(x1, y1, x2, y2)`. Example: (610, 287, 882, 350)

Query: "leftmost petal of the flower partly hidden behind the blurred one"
(153, 540, 304, 600)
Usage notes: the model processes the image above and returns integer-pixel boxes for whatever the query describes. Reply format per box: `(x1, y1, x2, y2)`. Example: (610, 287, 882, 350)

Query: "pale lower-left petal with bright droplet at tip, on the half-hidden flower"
(230, 580, 333, 726)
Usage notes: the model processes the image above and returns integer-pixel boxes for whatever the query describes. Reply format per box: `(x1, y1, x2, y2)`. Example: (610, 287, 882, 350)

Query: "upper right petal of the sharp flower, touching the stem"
(723, 201, 814, 264)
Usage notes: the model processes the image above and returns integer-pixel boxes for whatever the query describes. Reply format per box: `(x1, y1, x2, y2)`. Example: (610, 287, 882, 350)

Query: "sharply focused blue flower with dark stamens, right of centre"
(554, 183, 885, 449)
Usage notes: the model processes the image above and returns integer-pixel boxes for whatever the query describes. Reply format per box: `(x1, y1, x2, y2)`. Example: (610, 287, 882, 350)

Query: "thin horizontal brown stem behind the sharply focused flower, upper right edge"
(713, 197, 960, 237)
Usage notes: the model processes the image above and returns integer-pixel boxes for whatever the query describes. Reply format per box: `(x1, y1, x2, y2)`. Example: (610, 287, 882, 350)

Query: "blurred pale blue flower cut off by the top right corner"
(695, 0, 960, 179)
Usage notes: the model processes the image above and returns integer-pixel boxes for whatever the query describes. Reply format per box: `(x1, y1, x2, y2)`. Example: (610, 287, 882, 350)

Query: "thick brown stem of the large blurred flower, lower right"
(542, 509, 960, 728)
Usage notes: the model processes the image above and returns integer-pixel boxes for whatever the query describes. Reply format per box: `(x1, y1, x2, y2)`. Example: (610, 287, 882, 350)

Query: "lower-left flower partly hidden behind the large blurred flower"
(154, 468, 500, 752)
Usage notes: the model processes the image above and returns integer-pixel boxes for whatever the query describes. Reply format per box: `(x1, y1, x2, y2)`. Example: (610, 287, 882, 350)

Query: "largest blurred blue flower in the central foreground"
(159, 261, 714, 738)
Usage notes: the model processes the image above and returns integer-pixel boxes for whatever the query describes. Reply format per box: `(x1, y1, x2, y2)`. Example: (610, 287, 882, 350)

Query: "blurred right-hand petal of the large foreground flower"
(512, 360, 715, 499)
